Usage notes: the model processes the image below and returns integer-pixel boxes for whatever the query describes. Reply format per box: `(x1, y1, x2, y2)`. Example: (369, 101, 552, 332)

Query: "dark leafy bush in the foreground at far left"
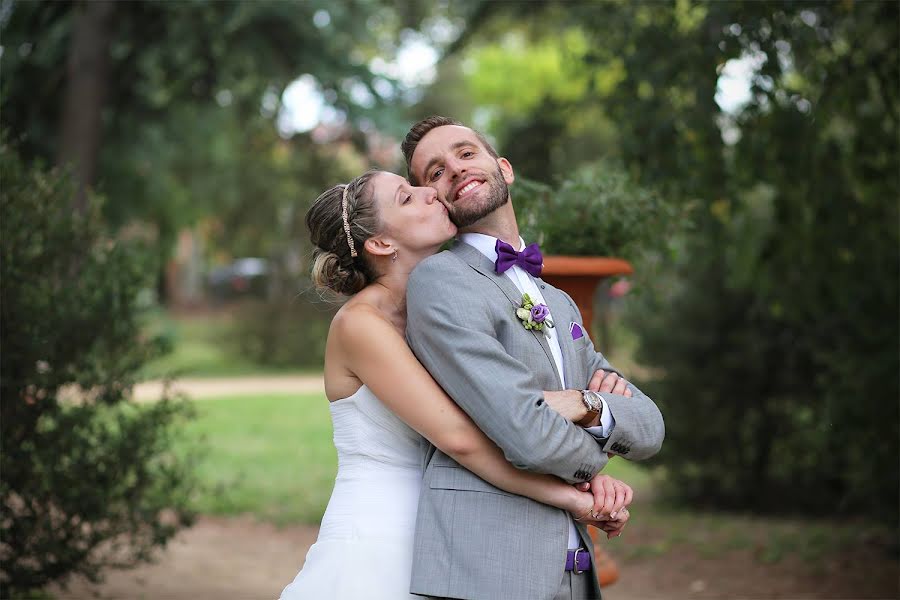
(0, 143, 191, 598)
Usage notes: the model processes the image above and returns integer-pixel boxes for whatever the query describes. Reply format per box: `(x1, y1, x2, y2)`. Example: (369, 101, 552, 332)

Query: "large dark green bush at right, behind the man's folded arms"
(634, 132, 900, 523)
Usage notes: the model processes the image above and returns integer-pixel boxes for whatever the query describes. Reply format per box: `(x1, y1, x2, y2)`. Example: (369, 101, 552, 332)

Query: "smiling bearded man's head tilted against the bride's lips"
(409, 125, 515, 228)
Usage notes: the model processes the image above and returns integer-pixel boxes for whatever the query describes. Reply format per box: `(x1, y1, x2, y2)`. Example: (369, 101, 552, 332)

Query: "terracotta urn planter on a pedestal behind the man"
(541, 256, 634, 587)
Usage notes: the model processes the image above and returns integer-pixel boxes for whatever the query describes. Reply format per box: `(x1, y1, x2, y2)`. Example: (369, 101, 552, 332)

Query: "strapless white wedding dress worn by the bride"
(281, 386, 428, 600)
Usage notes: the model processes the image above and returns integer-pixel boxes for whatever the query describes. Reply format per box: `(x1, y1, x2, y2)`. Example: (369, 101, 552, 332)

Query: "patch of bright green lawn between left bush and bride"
(178, 394, 337, 525)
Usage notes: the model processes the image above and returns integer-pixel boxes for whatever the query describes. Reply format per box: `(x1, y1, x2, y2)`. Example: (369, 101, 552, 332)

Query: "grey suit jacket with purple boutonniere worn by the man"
(407, 242, 664, 600)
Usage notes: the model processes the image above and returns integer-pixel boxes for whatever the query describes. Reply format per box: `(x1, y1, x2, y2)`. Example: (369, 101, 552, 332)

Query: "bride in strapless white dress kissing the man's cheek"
(281, 171, 632, 600)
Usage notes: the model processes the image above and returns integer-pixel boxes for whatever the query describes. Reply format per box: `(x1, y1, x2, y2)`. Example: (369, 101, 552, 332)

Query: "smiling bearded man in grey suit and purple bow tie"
(403, 117, 664, 600)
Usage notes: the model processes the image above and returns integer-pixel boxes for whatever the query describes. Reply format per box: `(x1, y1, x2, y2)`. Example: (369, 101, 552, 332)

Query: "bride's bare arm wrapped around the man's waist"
(332, 305, 600, 518)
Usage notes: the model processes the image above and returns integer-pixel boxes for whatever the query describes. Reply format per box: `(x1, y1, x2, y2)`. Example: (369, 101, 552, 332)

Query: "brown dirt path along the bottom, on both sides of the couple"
(51, 517, 898, 600)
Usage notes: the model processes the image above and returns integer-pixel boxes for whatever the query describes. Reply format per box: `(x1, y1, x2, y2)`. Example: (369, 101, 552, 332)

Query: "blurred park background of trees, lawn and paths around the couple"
(0, 0, 900, 600)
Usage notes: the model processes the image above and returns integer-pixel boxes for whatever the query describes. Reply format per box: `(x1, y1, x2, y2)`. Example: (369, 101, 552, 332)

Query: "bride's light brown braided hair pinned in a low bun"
(306, 171, 380, 296)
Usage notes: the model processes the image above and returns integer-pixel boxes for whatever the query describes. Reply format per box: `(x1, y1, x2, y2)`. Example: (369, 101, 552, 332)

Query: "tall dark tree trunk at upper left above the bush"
(58, 0, 114, 211)
